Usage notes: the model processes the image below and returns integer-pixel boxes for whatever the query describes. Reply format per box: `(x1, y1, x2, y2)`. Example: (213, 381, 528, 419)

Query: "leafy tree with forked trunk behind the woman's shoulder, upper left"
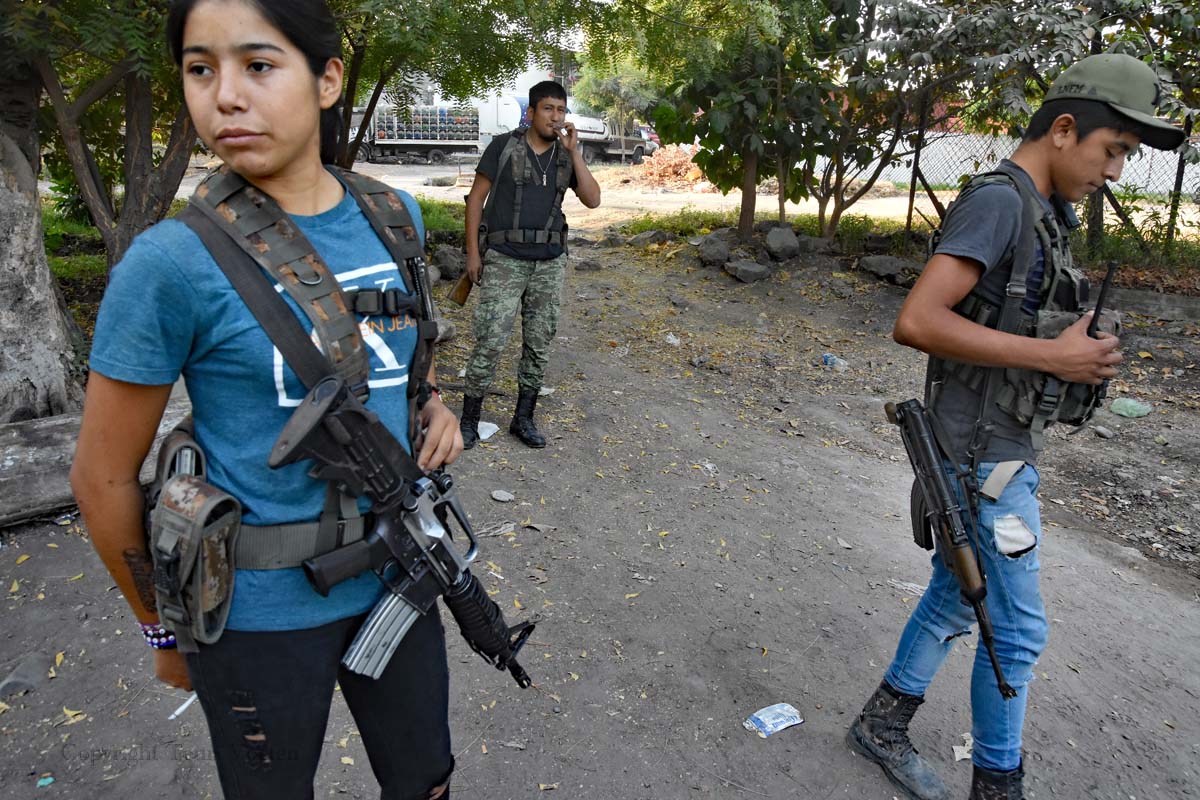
(0, 0, 196, 266)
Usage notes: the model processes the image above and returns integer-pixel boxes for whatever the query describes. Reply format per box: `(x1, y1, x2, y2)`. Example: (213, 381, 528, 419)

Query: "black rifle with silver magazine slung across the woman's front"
(268, 377, 534, 688)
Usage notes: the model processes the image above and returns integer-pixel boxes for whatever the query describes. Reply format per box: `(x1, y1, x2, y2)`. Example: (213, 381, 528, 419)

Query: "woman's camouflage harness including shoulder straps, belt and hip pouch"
(149, 167, 437, 650)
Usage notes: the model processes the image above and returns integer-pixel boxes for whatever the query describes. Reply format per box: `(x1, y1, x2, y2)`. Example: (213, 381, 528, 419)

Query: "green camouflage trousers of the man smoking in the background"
(463, 251, 566, 397)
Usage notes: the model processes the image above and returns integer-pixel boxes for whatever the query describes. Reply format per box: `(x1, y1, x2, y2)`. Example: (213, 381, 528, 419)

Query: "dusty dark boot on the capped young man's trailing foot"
(846, 681, 945, 800)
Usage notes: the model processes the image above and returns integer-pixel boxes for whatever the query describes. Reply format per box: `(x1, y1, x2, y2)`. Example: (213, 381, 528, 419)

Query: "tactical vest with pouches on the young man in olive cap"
(925, 164, 1120, 456)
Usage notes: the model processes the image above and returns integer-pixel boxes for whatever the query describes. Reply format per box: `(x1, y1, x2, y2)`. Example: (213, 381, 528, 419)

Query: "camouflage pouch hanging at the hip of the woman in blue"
(150, 473, 241, 652)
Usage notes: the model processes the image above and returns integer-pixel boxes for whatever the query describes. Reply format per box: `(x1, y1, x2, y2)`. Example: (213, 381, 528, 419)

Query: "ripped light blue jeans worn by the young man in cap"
(884, 463, 1048, 771)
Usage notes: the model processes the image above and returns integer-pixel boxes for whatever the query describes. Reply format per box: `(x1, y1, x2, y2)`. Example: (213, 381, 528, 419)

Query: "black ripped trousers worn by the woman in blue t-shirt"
(187, 612, 454, 800)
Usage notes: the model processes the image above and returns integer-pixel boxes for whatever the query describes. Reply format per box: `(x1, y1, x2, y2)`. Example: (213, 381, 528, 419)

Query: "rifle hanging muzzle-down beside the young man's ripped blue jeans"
(884, 399, 1016, 699)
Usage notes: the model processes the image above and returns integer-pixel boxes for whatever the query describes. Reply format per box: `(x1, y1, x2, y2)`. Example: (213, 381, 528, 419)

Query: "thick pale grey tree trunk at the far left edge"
(0, 108, 83, 423)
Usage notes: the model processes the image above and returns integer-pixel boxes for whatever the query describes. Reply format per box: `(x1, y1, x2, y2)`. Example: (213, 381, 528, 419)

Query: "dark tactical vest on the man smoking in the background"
(479, 127, 574, 253)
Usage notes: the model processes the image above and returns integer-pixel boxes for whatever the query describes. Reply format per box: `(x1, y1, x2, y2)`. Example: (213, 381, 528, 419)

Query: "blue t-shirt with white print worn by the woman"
(91, 181, 425, 631)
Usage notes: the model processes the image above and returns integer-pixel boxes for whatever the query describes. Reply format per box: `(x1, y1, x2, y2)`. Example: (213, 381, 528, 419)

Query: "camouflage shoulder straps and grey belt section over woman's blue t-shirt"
(178, 167, 437, 567)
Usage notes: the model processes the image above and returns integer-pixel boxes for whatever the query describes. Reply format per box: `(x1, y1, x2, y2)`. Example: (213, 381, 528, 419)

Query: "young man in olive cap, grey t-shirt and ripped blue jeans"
(847, 55, 1183, 800)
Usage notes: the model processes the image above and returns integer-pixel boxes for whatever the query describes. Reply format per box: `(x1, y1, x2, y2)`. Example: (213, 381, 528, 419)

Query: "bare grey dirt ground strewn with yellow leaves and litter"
(0, 172, 1200, 800)
